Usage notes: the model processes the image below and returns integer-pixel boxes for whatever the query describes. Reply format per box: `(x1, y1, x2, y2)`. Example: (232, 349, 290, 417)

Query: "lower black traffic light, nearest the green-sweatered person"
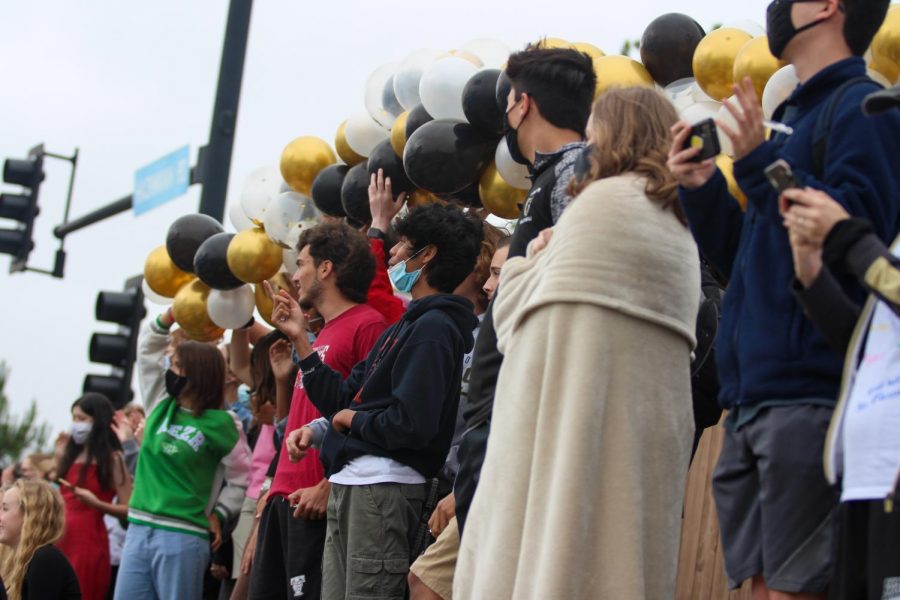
(83, 276, 147, 408)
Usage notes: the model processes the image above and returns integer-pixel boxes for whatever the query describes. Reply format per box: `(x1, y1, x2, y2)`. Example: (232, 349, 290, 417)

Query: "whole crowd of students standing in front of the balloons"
(0, 0, 900, 600)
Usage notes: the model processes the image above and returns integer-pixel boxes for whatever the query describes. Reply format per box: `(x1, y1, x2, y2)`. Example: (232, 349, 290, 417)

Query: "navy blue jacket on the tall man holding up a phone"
(679, 58, 900, 408)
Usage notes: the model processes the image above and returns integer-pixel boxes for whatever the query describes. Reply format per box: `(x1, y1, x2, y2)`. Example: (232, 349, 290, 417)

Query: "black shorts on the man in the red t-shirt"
(249, 496, 327, 600)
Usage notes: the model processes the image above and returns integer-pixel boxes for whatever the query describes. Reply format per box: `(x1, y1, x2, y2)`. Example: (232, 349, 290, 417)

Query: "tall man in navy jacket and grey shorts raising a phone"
(669, 0, 900, 598)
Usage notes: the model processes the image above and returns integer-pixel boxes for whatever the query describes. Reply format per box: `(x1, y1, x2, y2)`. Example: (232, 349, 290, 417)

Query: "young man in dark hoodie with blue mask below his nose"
(272, 204, 482, 600)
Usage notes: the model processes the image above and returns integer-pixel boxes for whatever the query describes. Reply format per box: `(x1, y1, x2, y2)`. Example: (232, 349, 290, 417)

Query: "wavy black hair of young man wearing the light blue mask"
(394, 204, 484, 294)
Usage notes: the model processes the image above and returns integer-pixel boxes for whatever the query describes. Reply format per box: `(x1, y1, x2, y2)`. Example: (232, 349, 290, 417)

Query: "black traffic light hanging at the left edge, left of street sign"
(0, 145, 44, 273)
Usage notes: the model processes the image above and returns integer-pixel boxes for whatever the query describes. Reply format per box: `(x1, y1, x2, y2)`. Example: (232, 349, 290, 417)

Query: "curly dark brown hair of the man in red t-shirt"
(297, 223, 375, 303)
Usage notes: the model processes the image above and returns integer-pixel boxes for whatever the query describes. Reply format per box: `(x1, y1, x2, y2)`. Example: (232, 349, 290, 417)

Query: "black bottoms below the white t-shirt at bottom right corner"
(830, 500, 900, 600)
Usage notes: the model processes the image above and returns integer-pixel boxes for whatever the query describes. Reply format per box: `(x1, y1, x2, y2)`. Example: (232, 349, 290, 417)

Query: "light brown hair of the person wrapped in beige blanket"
(569, 87, 687, 224)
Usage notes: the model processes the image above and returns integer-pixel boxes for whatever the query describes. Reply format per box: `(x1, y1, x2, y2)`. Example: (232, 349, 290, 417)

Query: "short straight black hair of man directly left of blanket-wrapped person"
(504, 44, 597, 135)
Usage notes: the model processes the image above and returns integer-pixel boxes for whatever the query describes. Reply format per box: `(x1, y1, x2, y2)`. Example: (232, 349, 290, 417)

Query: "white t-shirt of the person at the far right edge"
(841, 302, 900, 502)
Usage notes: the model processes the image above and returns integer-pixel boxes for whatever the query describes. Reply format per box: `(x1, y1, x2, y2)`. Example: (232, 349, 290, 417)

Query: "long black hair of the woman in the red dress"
(56, 392, 122, 490)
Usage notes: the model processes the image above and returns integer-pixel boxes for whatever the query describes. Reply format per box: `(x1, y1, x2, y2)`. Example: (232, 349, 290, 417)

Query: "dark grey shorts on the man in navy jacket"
(712, 404, 839, 593)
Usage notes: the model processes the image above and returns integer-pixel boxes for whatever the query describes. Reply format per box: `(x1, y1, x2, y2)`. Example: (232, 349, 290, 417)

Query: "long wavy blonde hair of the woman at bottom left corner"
(3, 479, 66, 600)
